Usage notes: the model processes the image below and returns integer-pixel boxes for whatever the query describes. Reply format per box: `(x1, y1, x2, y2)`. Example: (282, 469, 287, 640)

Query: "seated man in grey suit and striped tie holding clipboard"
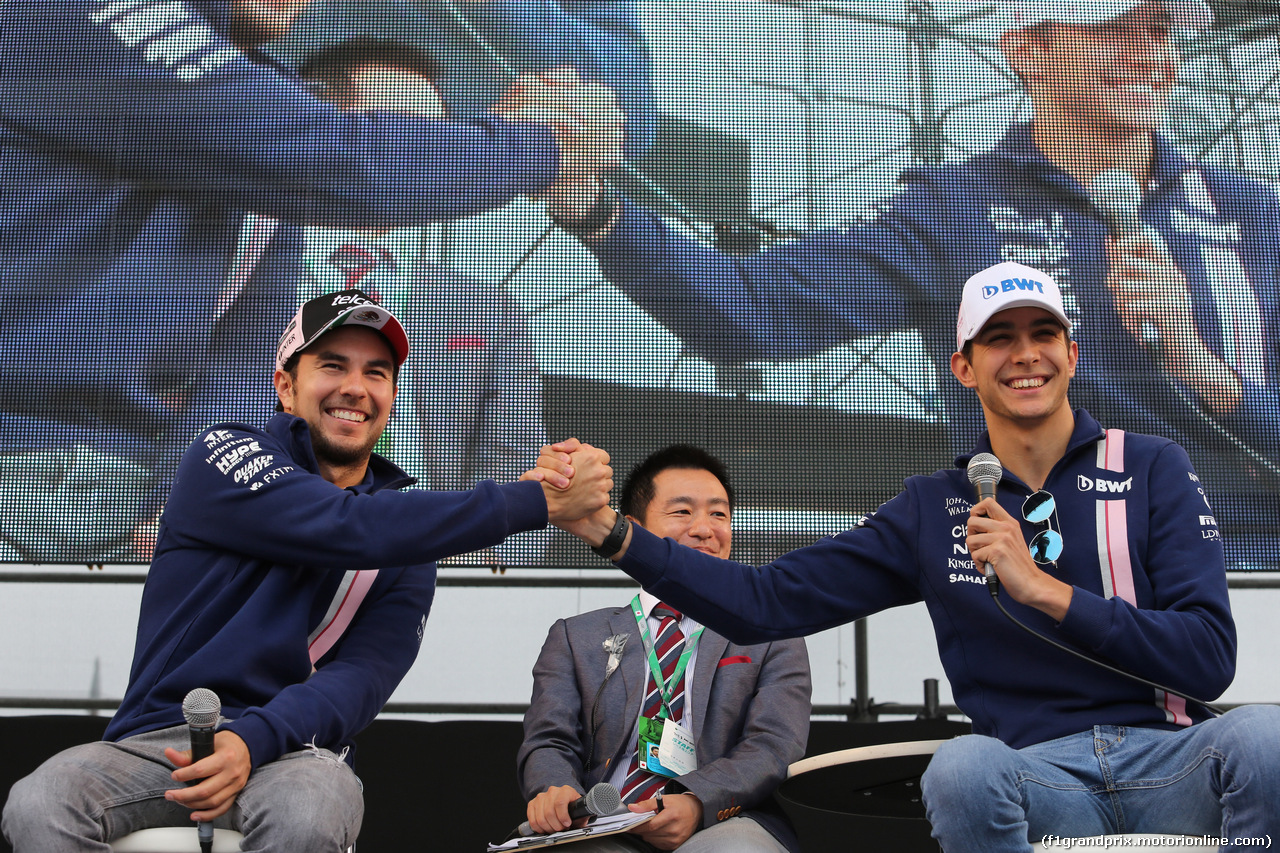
(517, 444, 812, 853)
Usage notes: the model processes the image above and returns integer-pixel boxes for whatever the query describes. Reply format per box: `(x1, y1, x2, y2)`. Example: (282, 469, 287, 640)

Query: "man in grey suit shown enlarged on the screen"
(298, 38, 552, 567)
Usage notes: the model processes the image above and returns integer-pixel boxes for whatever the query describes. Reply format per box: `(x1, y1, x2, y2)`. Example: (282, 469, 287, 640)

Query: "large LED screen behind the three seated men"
(0, 0, 1280, 569)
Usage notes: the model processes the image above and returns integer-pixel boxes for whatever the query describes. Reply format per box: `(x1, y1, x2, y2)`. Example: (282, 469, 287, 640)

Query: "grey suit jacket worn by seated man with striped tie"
(517, 607, 813, 850)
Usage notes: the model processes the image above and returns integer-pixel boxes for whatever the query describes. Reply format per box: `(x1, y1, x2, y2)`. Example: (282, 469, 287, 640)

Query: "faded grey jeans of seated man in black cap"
(3, 726, 365, 853)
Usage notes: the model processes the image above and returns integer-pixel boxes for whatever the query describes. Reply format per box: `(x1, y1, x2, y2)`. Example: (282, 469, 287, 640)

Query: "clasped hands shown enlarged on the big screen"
(493, 68, 626, 219)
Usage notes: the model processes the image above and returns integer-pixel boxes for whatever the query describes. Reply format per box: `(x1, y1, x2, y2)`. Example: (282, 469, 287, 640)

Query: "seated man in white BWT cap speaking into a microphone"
(539, 263, 1280, 853)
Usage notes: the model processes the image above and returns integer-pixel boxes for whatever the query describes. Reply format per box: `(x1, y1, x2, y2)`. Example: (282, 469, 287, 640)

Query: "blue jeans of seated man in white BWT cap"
(922, 704, 1280, 853)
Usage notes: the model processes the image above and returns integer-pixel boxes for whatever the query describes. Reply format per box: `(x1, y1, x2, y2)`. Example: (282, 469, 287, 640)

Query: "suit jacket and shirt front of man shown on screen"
(298, 228, 552, 565)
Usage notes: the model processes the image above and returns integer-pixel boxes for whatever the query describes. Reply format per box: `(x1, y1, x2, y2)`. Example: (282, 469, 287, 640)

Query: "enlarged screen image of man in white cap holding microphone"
(542, 0, 1280, 566)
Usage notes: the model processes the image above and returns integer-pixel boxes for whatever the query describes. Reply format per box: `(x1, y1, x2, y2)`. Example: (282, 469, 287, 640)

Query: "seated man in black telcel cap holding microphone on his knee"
(4, 291, 612, 853)
